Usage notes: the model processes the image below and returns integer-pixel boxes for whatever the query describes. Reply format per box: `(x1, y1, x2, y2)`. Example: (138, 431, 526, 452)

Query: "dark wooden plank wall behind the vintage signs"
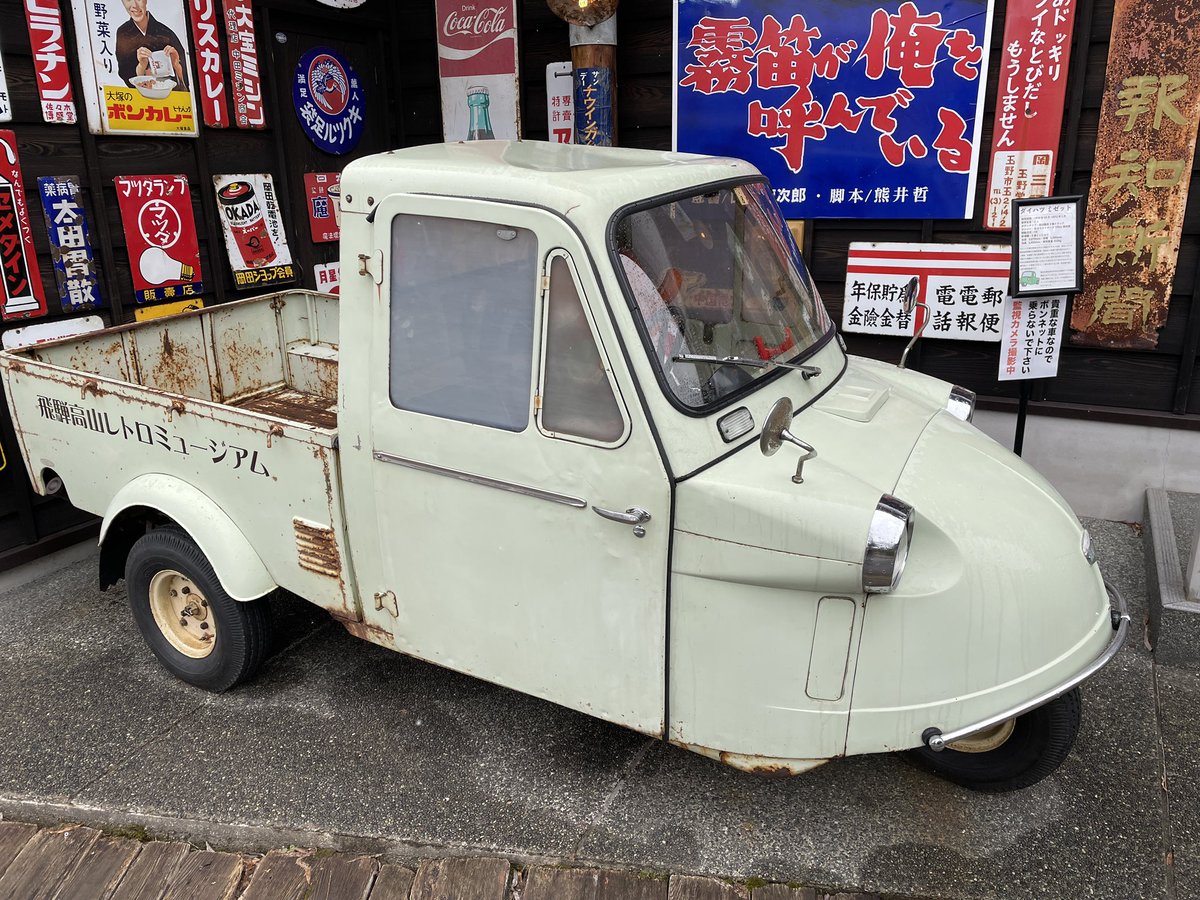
(0, 0, 1200, 569)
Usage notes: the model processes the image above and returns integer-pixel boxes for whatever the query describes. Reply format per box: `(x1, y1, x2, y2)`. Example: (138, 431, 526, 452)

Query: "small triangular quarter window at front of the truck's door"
(539, 256, 625, 444)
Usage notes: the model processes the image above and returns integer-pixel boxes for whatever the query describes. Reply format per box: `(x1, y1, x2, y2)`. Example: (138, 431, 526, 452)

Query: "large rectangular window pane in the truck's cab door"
(389, 216, 538, 431)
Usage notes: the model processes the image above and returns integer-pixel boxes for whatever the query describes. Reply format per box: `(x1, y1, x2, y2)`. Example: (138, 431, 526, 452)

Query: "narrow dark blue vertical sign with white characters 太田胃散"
(37, 175, 103, 312)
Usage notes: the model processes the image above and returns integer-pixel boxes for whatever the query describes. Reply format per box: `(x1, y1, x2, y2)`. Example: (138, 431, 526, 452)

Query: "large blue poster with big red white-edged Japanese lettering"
(674, 0, 994, 218)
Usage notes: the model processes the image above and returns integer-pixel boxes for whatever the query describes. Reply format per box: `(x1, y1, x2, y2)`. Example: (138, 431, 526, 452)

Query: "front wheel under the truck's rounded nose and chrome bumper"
(907, 688, 1081, 793)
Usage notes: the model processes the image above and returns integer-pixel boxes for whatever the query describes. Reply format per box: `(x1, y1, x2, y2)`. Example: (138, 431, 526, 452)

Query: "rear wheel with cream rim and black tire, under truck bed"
(125, 528, 270, 692)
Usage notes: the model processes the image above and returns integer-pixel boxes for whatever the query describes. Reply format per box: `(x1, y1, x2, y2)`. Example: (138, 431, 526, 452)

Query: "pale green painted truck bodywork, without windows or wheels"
(0, 142, 1114, 772)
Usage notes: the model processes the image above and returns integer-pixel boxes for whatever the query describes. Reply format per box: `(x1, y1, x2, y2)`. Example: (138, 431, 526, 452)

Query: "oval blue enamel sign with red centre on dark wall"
(292, 47, 365, 155)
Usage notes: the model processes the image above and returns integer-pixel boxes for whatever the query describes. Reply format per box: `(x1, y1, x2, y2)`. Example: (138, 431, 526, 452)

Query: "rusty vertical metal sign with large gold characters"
(1070, 0, 1200, 349)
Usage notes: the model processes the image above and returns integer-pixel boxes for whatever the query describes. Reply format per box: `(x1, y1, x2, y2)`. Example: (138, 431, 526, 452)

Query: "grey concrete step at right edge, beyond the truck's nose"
(1142, 488, 1200, 667)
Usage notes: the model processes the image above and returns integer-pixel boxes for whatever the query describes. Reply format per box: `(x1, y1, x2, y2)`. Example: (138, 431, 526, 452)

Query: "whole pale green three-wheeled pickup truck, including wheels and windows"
(0, 142, 1128, 791)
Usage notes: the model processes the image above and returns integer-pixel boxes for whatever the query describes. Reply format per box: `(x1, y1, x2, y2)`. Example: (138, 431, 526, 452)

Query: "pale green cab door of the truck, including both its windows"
(355, 196, 671, 734)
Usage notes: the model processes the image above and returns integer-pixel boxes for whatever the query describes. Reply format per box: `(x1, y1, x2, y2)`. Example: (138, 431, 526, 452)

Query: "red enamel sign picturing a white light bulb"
(113, 175, 204, 304)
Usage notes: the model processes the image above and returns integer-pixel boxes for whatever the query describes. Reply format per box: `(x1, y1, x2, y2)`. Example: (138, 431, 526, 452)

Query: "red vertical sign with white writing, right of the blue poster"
(983, 0, 1075, 230)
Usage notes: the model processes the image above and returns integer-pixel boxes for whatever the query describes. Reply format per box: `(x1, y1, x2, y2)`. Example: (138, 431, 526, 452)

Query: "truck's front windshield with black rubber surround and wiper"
(616, 184, 829, 410)
